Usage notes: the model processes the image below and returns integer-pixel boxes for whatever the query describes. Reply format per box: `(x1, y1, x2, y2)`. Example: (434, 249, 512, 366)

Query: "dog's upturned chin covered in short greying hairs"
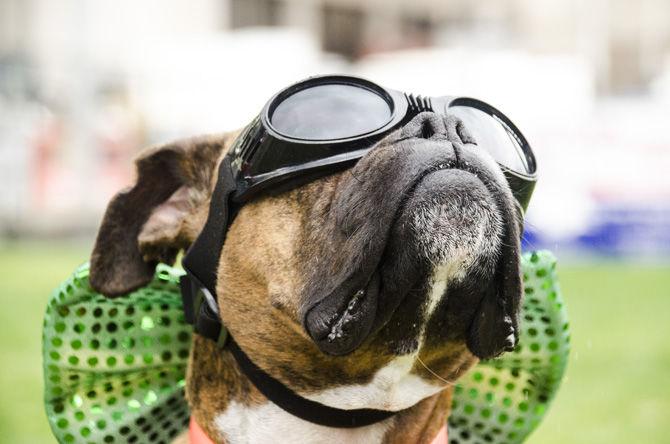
(394, 169, 504, 280)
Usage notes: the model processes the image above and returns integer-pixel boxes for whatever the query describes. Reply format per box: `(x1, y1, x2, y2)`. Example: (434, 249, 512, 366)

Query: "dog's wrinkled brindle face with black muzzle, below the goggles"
(218, 113, 521, 406)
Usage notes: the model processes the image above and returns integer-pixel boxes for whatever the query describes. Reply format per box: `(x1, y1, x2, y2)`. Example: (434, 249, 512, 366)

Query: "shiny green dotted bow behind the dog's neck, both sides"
(43, 251, 570, 444)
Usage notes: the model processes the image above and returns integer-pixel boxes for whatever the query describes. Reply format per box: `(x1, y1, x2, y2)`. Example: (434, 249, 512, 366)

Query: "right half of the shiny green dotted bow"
(449, 251, 570, 444)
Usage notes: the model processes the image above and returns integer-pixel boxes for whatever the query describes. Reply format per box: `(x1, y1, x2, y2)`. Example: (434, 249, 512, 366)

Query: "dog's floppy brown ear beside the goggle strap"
(90, 134, 233, 296)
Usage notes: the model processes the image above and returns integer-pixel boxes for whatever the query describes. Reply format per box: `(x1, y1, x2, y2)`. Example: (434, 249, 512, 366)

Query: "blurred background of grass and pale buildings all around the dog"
(0, 0, 670, 443)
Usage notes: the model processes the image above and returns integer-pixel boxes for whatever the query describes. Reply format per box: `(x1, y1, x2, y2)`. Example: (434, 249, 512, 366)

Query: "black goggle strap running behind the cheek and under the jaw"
(180, 156, 397, 428)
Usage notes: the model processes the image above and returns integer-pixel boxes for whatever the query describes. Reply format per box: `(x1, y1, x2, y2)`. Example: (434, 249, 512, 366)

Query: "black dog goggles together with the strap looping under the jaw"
(180, 76, 536, 428)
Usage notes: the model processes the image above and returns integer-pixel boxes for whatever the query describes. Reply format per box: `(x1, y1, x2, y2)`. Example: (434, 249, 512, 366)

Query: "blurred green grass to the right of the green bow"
(529, 263, 670, 444)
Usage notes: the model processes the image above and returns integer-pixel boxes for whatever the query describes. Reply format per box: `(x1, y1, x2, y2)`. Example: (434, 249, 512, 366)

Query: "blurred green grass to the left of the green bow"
(0, 243, 89, 444)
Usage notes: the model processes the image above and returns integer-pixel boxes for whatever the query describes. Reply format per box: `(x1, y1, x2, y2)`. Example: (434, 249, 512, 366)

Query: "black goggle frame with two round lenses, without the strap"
(229, 75, 537, 209)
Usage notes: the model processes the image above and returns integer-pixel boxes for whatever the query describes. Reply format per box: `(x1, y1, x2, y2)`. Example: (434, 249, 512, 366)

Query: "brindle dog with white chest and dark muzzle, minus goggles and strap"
(90, 112, 523, 443)
